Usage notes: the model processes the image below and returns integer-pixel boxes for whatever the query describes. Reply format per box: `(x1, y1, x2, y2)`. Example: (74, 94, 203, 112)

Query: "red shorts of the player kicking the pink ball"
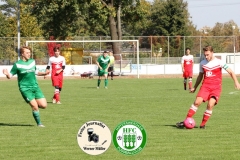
(197, 84, 222, 103)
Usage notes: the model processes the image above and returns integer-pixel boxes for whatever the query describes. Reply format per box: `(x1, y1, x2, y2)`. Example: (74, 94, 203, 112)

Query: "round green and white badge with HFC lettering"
(113, 120, 147, 155)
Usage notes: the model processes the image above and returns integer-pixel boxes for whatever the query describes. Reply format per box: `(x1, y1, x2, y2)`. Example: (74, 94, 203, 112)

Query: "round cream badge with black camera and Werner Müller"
(77, 121, 112, 155)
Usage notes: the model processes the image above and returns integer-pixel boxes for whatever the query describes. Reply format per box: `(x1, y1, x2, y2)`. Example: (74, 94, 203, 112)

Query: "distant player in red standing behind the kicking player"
(181, 48, 194, 90)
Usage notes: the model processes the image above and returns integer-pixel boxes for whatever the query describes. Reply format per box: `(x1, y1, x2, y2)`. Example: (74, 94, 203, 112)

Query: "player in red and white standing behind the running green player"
(46, 47, 66, 104)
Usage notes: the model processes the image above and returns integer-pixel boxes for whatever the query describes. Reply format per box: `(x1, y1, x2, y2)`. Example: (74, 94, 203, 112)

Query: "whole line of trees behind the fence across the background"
(0, 0, 240, 57)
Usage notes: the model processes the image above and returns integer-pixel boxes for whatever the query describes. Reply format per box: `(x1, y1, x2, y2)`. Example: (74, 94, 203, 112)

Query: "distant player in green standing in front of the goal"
(96, 51, 110, 89)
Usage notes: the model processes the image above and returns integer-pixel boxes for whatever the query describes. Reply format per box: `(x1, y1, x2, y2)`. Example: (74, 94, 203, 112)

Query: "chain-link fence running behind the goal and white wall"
(0, 36, 240, 65)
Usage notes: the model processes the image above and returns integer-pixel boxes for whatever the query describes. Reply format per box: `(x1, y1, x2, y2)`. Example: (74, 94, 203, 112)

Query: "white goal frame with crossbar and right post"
(26, 40, 139, 79)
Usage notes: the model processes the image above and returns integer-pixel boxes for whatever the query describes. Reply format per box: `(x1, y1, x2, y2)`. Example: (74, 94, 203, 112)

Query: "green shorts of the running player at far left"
(20, 87, 45, 103)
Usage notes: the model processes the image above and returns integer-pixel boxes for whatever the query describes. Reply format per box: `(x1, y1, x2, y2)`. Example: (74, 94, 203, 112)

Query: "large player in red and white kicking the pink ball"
(176, 46, 240, 129)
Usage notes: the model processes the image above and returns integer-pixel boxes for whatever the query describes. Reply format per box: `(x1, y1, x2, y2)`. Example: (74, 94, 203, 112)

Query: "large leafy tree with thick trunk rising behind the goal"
(24, 0, 145, 54)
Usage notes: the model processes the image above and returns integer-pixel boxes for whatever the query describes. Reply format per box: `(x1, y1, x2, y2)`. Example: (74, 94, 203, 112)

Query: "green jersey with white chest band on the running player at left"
(10, 59, 38, 91)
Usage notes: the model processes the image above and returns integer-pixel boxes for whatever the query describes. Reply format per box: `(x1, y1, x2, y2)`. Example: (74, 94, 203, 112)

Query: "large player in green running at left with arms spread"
(3, 46, 49, 127)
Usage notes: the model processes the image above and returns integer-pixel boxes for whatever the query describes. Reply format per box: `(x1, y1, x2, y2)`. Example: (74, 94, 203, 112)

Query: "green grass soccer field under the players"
(0, 78, 240, 160)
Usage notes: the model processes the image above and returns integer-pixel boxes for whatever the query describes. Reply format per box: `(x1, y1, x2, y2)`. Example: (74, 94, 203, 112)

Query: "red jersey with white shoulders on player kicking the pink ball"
(200, 57, 228, 85)
